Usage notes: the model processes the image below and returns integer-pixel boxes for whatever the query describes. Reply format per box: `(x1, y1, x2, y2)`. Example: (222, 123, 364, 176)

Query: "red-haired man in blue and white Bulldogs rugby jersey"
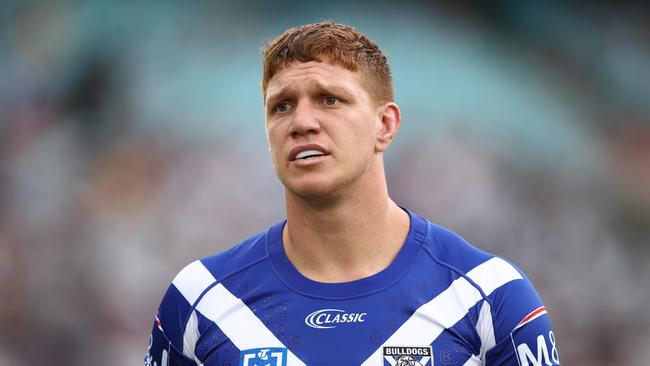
(145, 22, 559, 366)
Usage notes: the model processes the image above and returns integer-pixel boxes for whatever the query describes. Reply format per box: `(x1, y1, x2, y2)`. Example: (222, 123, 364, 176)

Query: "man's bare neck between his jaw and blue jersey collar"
(282, 166, 409, 282)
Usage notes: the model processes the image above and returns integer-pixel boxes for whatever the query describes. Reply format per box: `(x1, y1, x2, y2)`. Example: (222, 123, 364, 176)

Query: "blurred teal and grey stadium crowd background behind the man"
(0, 0, 650, 366)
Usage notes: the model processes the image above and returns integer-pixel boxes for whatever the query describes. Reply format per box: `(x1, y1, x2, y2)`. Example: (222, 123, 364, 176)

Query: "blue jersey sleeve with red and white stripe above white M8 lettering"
(484, 266, 560, 366)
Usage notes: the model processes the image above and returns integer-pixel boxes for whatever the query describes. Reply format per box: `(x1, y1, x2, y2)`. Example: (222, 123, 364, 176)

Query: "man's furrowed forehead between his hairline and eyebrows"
(266, 61, 363, 100)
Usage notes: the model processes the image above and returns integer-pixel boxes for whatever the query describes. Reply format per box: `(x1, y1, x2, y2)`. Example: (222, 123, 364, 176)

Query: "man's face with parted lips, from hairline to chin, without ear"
(265, 61, 381, 198)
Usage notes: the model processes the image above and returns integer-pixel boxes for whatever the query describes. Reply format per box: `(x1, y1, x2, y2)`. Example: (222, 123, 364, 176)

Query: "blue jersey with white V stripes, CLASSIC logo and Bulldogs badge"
(145, 212, 560, 366)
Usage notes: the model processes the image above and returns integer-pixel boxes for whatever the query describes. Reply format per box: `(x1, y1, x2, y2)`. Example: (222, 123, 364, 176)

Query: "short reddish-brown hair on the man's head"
(262, 21, 393, 104)
